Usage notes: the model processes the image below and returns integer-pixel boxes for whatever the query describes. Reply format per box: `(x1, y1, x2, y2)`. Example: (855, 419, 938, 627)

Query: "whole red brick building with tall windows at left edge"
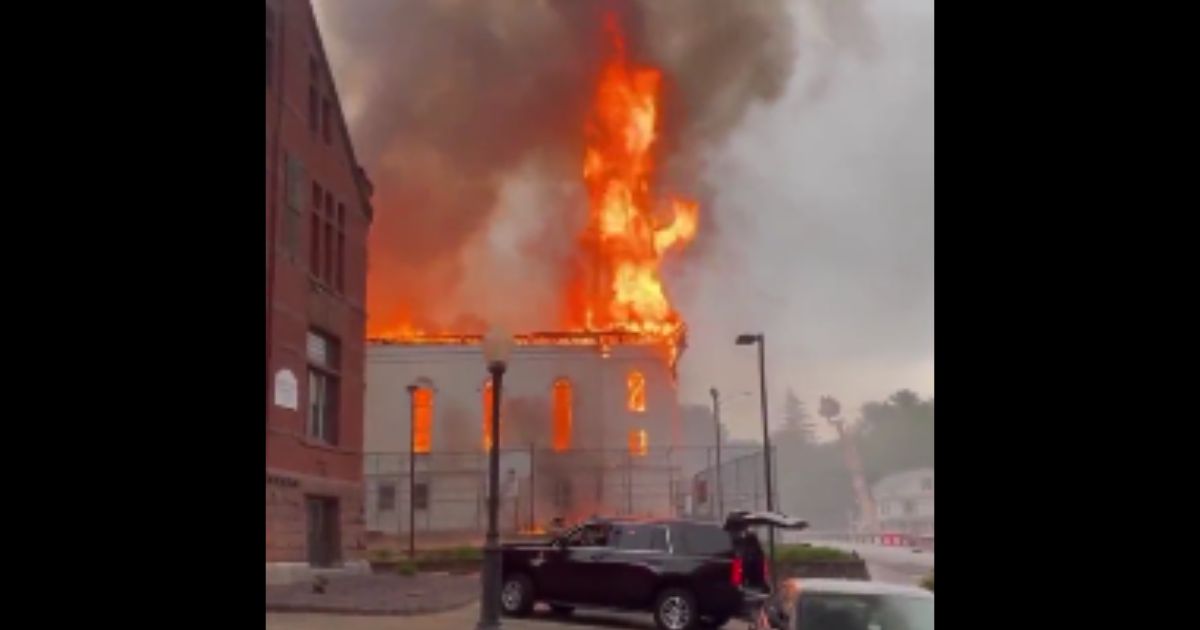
(265, 0, 372, 580)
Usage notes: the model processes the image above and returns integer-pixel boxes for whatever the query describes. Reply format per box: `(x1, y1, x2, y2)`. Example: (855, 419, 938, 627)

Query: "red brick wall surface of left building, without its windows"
(265, 0, 371, 560)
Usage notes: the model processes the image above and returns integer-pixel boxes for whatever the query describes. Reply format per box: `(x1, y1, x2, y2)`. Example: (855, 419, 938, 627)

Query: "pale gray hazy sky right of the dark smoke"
(314, 0, 934, 439)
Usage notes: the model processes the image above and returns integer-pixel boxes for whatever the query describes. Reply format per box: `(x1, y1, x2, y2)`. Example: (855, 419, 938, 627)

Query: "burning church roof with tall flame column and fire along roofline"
(370, 14, 700, 379)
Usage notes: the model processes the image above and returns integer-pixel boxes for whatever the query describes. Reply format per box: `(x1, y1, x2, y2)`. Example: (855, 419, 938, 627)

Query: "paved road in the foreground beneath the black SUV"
(266, 604, 729, 630)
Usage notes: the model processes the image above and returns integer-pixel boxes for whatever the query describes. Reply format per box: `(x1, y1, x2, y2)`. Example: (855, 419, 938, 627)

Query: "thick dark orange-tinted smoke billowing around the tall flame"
(317, 0, 859, 329)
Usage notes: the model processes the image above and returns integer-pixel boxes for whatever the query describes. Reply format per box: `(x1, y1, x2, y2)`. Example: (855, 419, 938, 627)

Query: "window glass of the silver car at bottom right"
(793, 593, 934, 630)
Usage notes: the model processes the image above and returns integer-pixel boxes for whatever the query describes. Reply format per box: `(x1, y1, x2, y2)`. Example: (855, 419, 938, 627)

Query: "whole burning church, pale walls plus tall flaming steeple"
(364, 9, 715, 536)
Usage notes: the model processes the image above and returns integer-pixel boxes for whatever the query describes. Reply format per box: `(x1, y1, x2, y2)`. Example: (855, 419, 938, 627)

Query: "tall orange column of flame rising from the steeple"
(569, 16, 698, 336)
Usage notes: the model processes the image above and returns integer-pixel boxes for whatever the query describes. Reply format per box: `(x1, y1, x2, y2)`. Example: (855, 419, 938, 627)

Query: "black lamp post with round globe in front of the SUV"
(476, 328, 512, 630)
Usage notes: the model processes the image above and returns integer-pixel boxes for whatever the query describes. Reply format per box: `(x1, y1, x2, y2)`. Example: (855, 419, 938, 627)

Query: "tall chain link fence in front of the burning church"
(364, 446, 754, 546)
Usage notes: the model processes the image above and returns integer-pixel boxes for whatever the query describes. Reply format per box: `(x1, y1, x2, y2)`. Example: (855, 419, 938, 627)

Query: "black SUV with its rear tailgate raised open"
(500, 512, 806, 630)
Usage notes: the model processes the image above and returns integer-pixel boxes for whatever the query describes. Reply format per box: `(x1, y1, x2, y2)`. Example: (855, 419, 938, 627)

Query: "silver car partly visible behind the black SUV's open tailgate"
(751, 578, 934, 630)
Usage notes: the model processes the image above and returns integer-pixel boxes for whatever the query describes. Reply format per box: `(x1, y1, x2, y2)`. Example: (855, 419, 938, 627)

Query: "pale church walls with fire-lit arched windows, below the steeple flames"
(365, 332, 684, 534)
